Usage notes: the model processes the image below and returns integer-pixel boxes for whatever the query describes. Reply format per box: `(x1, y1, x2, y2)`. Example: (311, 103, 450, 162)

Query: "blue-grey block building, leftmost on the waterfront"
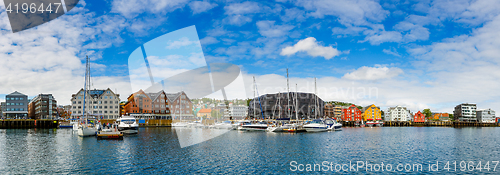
(4, 91, 29, 119)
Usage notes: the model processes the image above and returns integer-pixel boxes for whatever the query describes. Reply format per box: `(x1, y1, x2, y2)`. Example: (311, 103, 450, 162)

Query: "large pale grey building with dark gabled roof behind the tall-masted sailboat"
(71, 88, 120, 119)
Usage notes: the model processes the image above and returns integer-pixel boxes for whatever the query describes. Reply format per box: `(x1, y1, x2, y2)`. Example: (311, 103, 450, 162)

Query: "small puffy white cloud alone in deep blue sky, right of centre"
(280, 37, 340, 59)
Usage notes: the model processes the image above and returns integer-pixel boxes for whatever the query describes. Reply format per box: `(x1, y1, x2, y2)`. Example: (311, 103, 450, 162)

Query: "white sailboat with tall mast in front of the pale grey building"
(78, 56, 97, 137)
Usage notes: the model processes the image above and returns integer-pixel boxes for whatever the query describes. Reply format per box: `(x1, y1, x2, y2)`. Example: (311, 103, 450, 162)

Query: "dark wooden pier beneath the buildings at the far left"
(0, 119, 59, 129)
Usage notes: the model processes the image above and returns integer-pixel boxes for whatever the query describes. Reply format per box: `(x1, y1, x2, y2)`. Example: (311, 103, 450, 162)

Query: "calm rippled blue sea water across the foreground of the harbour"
(0, 127, 500, 174)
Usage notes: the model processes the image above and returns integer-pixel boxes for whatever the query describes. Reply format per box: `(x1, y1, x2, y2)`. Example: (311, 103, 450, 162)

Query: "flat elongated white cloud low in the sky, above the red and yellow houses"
(342, 66, 403, 80)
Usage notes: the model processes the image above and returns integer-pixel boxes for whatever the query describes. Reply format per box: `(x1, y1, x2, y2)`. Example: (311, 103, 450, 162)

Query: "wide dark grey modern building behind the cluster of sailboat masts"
(248, 92, 325, 119)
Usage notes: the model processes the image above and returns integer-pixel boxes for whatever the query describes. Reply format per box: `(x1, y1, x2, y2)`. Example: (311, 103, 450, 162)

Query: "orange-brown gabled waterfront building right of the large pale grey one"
(123, 89, 171, 119)
